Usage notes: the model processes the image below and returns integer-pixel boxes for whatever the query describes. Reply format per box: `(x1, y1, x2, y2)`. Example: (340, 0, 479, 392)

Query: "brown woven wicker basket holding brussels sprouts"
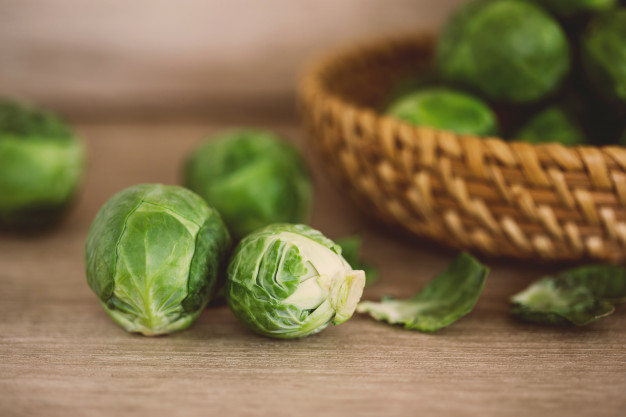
(299, 35, 626, 262)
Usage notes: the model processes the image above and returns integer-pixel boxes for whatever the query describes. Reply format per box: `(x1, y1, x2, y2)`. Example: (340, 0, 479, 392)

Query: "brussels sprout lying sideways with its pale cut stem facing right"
(226, 224, 365, 338)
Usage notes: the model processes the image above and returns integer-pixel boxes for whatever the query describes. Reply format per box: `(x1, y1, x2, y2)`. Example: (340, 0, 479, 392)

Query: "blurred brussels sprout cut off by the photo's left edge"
(0, 100, 85, 230)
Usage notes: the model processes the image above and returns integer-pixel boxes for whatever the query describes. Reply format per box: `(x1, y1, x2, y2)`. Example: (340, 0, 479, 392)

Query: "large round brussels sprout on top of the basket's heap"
(437, 0, 570, 103)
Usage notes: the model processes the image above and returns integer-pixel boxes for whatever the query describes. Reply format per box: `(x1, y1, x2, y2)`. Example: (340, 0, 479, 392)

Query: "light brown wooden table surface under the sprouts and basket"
(0, 124, 626, 417)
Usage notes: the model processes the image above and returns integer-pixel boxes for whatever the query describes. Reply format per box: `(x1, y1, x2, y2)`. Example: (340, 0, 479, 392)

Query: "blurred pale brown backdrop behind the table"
(0, 0, 463, 123)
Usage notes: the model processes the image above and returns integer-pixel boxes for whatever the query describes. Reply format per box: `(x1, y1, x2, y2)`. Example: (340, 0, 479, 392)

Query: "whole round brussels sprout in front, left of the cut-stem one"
(85, 184, 230, 336)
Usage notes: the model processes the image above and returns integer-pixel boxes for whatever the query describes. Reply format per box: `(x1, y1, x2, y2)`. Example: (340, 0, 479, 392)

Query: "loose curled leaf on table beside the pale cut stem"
(357, 253, 489, 332)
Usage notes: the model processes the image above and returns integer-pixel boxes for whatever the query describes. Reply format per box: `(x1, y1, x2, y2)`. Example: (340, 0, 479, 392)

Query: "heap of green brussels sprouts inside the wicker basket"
(386, 0, 626, 146)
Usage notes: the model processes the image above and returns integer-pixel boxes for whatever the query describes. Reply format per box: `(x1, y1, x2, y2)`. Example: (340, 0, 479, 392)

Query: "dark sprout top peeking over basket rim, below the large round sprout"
(515, 106, 585, 146)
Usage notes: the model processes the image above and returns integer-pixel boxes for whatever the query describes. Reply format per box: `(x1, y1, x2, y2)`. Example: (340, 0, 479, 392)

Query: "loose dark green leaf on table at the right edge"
(511, 265, 626, 326)
